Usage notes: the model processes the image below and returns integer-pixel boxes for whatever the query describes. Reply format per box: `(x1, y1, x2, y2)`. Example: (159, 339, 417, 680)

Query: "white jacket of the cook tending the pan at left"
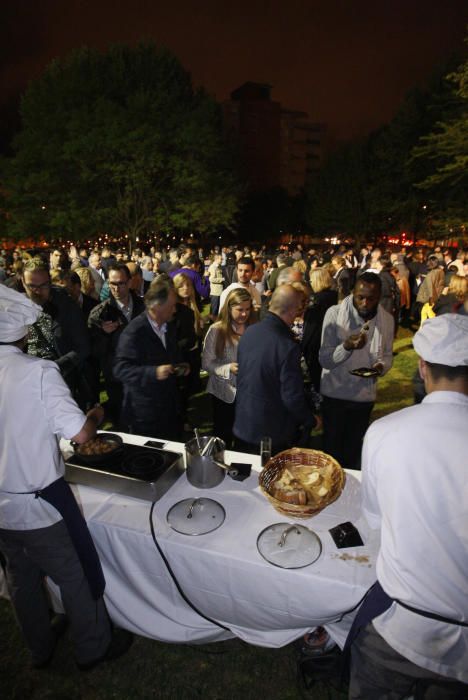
(0, 345, 86, 530)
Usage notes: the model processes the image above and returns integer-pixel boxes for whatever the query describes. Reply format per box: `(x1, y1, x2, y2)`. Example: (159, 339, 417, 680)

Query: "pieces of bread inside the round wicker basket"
(271, 464, 336, 505)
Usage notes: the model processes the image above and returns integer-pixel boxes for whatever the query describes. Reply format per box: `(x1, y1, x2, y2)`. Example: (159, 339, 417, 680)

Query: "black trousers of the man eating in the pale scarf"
(322, 396, 374, 469)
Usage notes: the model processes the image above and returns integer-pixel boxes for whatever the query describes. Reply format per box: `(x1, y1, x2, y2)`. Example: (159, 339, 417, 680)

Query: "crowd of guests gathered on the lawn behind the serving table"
(0, 244, 468, 468)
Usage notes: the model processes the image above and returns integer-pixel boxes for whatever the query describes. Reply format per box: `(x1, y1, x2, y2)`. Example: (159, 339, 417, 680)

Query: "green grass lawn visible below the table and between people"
(0, 329, 417, 700)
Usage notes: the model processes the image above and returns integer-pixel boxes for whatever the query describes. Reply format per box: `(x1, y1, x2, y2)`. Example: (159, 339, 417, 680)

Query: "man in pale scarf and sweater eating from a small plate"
(319, 272, 394, 469)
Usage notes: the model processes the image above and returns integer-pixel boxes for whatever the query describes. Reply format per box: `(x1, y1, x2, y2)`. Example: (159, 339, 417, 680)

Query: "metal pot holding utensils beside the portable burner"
(185, 436, 228, 489)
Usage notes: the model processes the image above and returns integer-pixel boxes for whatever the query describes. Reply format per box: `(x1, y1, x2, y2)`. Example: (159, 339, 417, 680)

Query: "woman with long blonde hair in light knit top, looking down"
(202, 287, 254, 448)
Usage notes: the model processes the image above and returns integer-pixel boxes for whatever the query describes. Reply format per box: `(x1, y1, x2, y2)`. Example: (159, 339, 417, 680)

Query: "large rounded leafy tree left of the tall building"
(2, 43, 240, 239)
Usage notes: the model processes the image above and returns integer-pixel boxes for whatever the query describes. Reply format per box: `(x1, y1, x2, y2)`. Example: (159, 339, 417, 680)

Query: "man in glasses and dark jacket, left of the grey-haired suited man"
(88, 263, 145, 423)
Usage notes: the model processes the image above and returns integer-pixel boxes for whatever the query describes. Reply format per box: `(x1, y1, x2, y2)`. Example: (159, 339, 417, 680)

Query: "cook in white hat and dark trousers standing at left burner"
(0, 285, 131, 670)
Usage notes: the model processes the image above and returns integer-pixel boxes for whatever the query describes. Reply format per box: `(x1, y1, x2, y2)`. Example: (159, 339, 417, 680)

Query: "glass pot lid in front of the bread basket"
(257, 523, 322, 569)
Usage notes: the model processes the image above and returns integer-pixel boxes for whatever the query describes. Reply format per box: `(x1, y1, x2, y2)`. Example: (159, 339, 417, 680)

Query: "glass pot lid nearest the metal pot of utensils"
(167, 498, 226, 535)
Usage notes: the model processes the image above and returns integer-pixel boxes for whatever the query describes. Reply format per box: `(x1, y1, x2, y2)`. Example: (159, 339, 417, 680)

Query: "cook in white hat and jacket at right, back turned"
(349, 314, 468, 700)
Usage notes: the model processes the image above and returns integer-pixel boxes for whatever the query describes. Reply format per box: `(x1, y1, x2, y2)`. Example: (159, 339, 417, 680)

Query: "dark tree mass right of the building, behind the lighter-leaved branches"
(307, 53, 460, 237)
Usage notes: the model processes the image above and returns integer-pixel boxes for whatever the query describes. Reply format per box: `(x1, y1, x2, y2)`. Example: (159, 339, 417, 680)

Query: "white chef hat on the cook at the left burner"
(0, 284, 42, 343)
